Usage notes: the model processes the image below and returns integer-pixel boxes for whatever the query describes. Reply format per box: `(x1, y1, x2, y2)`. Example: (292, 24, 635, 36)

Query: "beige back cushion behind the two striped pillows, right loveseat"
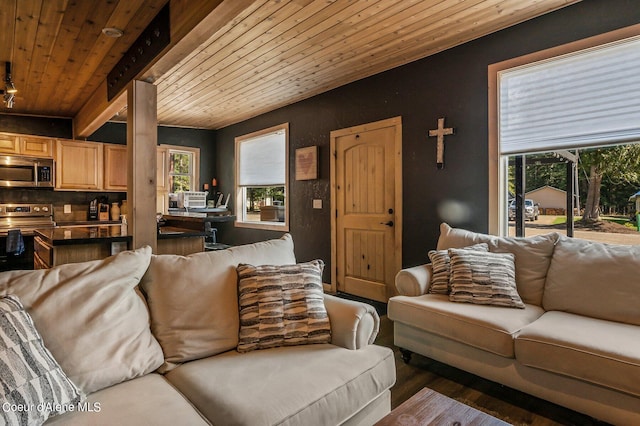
(437, 223, 560, 306)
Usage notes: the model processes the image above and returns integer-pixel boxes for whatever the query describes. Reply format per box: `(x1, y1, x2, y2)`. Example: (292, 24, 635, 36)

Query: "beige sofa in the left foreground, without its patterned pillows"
(0, 234, 395, 426)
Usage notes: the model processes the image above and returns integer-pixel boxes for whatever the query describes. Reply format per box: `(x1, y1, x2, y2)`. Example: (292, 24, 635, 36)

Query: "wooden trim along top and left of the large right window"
(487, 24, 640, 235)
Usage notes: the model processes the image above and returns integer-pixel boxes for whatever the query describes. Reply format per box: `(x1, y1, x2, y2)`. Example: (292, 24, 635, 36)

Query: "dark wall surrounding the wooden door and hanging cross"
(217, 0, 640, 274)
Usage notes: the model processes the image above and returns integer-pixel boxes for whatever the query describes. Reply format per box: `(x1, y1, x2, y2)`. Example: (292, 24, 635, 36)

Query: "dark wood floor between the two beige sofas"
(376, 315, 605, 426)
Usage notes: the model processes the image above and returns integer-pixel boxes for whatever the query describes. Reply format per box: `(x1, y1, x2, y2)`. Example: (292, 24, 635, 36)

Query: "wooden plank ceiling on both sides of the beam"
(0, 0, 576, 129)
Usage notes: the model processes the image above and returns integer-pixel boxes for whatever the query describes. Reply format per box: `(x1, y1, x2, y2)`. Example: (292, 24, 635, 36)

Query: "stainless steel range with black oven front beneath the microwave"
(0, 204, 56, 271)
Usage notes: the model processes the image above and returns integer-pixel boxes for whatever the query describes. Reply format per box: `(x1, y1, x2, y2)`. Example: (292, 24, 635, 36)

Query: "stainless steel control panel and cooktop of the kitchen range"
(0, 204, 56, 236)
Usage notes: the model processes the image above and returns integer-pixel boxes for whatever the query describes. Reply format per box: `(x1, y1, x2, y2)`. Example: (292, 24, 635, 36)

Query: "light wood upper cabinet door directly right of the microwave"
(55, 139, 104, 190)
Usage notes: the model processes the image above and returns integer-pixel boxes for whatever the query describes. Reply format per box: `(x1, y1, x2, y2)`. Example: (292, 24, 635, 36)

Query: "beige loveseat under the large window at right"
(388, 224, 640, 425)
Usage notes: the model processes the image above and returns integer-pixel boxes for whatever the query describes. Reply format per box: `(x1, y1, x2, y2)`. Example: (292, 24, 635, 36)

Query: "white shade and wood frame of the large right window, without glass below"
(490, 30, 640, 234)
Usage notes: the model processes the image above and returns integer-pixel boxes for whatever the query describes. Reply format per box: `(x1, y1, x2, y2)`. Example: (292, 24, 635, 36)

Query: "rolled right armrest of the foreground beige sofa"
(324, 294, 380, 349)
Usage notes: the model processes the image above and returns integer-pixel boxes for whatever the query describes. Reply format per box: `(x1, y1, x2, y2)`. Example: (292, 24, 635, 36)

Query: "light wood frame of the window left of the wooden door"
(234, 123, 290, 232)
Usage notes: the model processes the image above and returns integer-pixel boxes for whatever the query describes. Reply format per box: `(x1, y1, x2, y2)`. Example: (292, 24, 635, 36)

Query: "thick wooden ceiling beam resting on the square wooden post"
(73, 0, 253, 138)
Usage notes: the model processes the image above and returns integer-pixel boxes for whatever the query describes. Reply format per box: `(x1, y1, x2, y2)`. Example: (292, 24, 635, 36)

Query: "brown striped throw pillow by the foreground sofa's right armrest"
(237, 260, 331, 352)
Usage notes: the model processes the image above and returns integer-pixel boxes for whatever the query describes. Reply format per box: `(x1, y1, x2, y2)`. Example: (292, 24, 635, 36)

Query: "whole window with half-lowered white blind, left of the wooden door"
(235, 123, 289, 231)
